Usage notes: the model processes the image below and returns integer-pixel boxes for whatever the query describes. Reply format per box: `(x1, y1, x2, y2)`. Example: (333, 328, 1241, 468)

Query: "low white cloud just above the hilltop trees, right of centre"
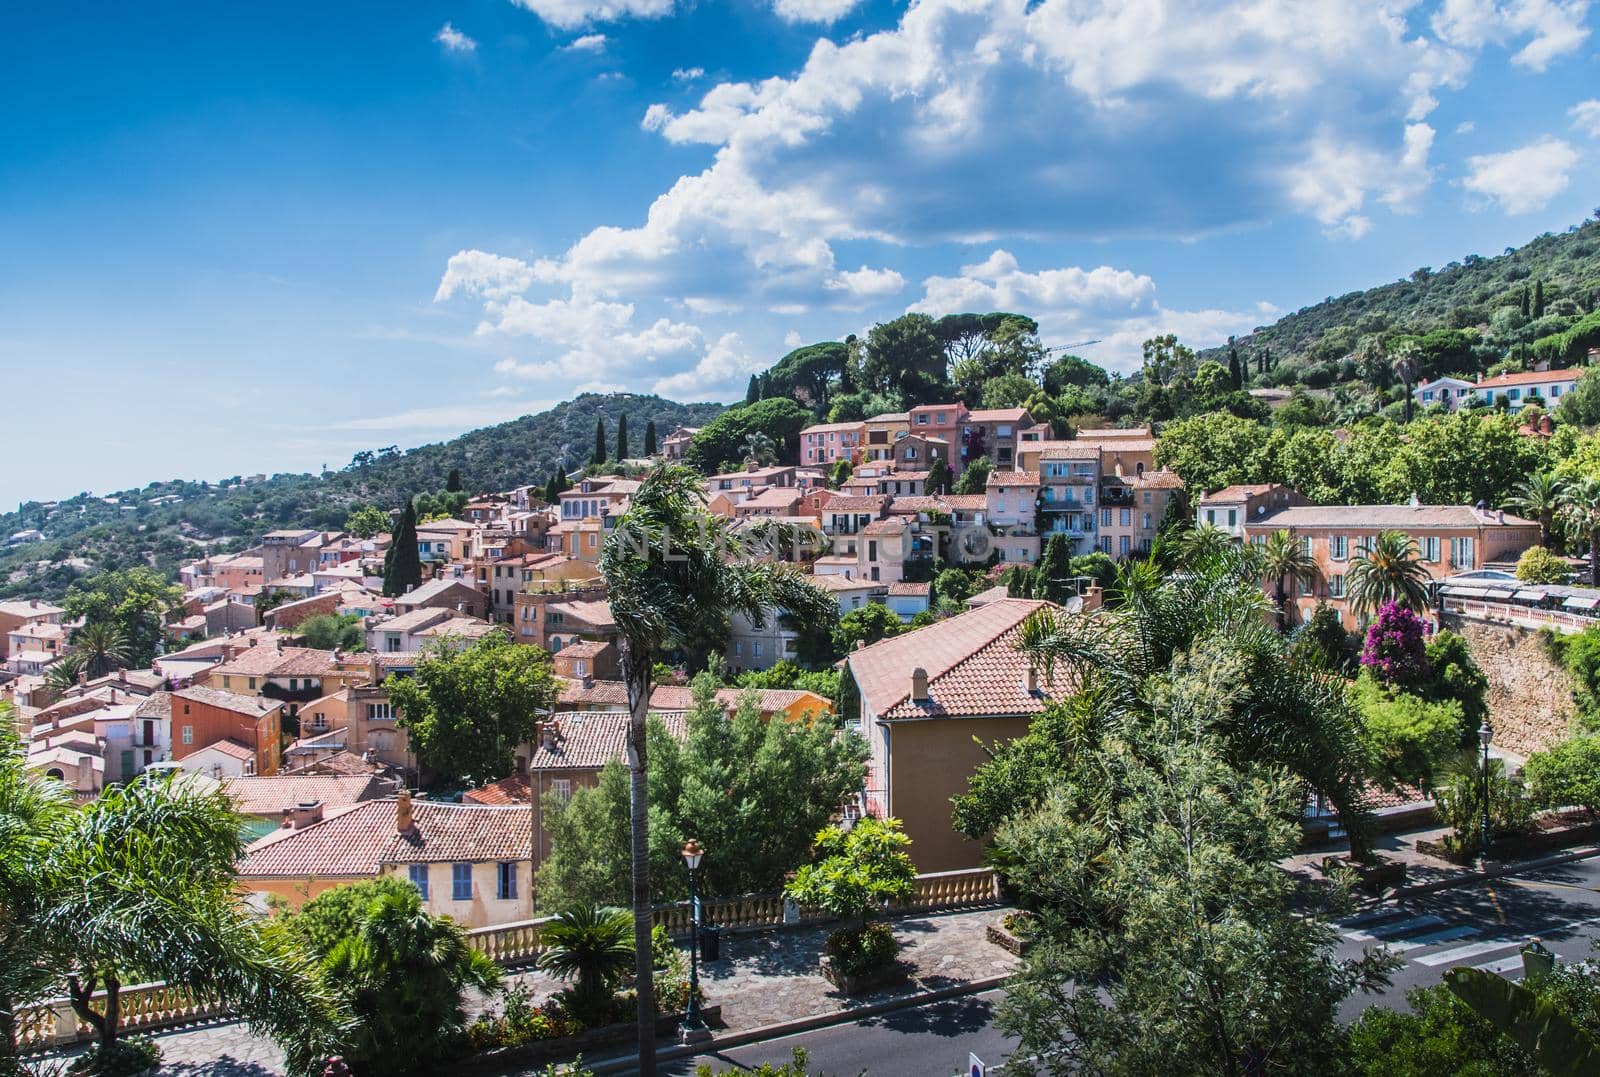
(909, 250, 1275, 370)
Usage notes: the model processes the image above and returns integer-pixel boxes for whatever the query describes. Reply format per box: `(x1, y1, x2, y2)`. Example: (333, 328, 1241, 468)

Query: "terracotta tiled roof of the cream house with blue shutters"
(237, 797, 533, 879)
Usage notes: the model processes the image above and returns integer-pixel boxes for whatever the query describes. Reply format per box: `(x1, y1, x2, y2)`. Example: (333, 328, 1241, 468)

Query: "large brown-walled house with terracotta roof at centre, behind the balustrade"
(845, 599, 1074, 872)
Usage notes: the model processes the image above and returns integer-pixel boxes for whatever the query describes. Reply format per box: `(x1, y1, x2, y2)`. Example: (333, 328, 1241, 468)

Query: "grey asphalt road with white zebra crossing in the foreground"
(662, 858, 1600, 1077)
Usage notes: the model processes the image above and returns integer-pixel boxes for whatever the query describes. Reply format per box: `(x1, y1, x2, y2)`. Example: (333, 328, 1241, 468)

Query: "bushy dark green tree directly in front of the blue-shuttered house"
(283, 875, 501, 1074)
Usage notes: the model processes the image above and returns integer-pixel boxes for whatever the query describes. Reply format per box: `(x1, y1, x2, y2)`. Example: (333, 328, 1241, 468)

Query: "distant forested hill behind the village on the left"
(0, 394, 723, 599)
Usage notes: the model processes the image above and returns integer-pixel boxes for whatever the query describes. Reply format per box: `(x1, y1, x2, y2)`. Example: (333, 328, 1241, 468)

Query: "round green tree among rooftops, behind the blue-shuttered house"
(389, 632, 558, 786)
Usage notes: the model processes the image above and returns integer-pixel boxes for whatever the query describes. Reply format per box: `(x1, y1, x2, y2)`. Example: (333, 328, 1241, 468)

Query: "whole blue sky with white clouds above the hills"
(0, 0, 1600, 504)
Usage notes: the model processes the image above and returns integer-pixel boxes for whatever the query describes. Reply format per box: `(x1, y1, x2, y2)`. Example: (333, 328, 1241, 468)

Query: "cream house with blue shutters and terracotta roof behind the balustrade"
(235, 791, 533, 928)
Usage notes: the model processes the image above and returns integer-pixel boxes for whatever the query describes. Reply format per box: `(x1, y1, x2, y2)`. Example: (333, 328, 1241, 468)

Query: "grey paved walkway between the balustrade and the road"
(59, 909, 1018, 1077)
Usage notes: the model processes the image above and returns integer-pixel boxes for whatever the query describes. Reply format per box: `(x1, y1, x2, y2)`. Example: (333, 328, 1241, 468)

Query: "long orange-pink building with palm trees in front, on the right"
(1245, 504, 1539, 629)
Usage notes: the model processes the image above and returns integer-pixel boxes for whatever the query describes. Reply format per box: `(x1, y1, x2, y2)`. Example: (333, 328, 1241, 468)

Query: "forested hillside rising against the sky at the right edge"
(1202, 219, 1600, 386)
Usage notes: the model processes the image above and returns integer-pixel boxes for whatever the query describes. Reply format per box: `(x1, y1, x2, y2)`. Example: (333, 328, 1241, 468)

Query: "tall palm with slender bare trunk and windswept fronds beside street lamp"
(600, 462, 838, 1077)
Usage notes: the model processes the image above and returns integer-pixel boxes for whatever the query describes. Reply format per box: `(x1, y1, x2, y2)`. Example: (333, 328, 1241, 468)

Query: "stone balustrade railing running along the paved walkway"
(16, 867, 1000, 1050)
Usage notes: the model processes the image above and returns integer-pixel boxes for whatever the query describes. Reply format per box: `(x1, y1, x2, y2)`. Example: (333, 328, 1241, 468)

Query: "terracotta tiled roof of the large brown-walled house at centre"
(848, 599, 1072, 720)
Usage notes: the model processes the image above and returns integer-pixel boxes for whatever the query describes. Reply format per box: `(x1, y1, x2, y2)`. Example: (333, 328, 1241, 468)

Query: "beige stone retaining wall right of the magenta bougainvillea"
(1440, 615, 1576, 755)
